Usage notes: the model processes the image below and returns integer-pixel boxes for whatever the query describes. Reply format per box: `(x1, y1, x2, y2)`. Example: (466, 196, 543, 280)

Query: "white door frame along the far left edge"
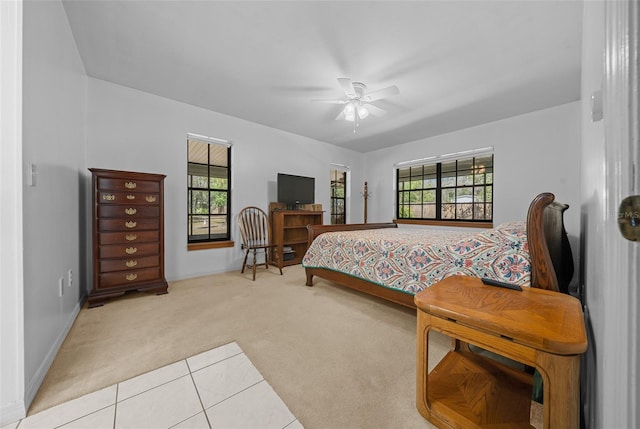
(0, 0, 26, 426)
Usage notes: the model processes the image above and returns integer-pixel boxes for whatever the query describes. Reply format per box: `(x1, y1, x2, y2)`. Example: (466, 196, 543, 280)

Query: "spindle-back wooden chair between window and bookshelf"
(238, 206, 282, 281)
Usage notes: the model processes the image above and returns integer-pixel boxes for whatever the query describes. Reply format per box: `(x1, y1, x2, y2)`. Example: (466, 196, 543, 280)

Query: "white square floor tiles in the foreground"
(2, 342, 302, 429)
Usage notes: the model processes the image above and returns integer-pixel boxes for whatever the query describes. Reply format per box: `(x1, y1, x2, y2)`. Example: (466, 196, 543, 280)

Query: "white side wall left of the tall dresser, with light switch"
(18, 1, 87, 418)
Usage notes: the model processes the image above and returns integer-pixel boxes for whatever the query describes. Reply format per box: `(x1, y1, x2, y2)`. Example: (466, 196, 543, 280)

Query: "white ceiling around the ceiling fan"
(63, 0, 582, 152)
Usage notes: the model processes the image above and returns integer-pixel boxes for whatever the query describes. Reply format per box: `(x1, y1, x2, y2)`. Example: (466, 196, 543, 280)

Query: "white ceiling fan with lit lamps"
(315, 77, 400, 133)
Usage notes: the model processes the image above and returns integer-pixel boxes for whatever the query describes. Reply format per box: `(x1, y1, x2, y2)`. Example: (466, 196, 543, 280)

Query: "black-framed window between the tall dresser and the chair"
(187, 135, 231, 244)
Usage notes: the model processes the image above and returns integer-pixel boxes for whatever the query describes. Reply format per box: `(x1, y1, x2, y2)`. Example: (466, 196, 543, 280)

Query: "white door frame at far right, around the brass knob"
(604, 0, 640, 428)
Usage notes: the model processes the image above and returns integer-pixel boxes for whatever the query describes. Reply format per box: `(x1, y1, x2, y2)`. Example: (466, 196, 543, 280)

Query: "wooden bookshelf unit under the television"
(270, 207, 323, 268)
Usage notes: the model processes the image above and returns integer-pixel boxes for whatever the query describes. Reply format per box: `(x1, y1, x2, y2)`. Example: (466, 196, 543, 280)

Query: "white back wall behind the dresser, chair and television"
(86, 79, 363, 280)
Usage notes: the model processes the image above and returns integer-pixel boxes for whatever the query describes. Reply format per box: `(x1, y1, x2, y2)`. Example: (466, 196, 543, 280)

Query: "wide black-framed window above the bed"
(396, 153, 493, 222)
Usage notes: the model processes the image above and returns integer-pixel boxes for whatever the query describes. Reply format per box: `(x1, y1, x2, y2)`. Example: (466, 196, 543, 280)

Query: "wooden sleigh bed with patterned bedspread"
(302, 192, 573, 308)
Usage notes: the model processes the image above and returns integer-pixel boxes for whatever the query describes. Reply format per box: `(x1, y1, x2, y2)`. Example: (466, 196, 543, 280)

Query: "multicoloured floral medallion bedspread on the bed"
(302, 222, 531, 295)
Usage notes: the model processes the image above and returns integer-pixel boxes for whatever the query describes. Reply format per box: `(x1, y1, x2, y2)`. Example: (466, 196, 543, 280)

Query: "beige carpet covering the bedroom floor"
(29, 265, 449, 429)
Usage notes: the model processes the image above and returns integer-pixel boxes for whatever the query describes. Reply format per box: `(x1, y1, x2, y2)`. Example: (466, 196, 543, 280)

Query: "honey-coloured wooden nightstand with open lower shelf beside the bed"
(415, 276, 587, 429)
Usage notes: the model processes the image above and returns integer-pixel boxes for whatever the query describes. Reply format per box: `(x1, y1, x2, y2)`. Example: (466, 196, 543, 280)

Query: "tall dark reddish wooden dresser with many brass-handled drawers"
(89, 168, 168, 308)
